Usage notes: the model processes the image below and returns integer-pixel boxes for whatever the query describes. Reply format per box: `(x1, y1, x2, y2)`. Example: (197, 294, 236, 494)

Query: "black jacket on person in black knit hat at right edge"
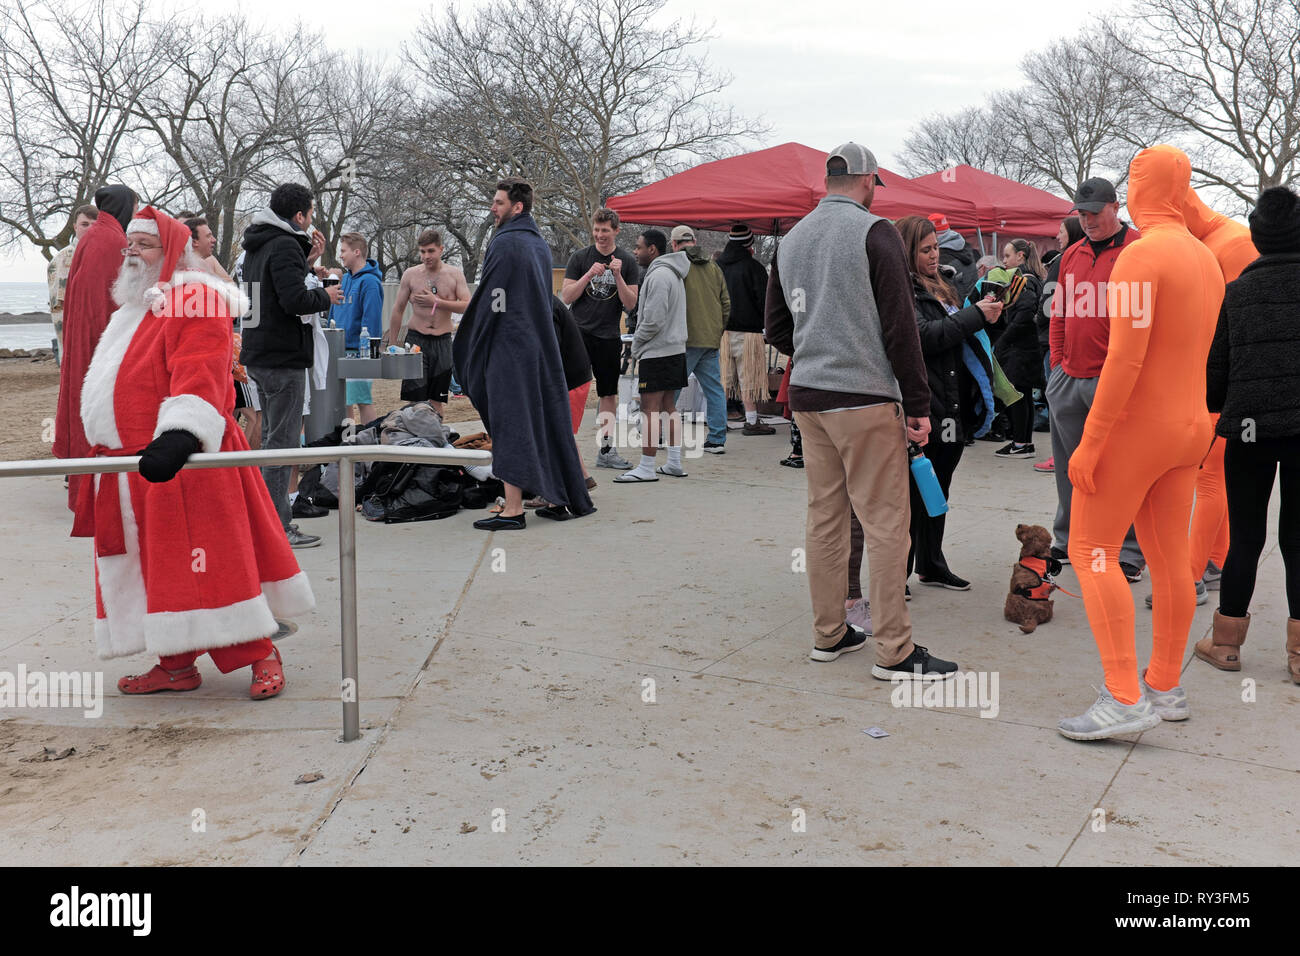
(1205, 254, 1300, 438)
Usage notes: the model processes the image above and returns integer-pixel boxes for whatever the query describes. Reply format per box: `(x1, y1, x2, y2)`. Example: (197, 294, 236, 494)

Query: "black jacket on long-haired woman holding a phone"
(913, 276, 984, 444)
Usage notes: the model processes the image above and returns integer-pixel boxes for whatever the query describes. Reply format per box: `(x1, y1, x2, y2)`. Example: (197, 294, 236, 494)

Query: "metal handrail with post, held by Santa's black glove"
(0, 445, 491, 741)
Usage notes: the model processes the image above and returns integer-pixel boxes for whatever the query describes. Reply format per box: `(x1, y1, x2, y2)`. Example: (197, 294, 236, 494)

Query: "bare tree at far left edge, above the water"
(0, 0, 163, 259)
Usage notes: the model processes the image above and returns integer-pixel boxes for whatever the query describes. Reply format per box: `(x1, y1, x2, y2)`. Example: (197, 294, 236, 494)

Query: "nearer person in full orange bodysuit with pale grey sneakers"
(1061, 146, 1223, 739)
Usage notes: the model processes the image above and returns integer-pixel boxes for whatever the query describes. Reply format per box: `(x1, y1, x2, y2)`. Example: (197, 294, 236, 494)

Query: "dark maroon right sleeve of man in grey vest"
(868, 226, 930, 418)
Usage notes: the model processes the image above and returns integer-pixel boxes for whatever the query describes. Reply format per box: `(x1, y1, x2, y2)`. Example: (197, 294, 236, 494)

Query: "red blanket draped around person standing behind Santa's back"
(53, 211, 126, 522)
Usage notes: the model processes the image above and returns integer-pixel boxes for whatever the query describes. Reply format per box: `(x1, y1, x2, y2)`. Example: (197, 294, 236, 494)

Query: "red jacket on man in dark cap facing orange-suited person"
(1048, 225, 1138, 378)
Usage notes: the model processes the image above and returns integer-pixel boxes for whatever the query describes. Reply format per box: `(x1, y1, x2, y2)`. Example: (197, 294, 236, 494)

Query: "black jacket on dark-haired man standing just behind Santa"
(239, 209, 330, 368)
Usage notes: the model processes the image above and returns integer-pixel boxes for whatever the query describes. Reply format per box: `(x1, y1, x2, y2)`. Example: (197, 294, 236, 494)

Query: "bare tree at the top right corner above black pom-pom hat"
(1108, 0, 1300, 204)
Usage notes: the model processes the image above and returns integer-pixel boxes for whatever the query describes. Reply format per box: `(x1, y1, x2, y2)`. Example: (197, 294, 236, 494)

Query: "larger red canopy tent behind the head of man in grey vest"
(608, 143, 976, 235)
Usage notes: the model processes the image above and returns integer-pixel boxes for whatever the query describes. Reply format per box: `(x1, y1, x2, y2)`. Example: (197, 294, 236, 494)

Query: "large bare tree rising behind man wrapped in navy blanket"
(404, 0, 764, 265)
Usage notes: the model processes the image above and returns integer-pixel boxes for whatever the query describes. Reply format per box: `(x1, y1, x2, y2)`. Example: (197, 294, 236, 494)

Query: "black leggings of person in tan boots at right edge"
(1219, 436, 1300, 619)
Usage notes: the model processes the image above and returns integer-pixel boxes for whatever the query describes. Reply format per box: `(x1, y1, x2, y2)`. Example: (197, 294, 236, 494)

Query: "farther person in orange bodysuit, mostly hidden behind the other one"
(1183, 189, 1260, 581)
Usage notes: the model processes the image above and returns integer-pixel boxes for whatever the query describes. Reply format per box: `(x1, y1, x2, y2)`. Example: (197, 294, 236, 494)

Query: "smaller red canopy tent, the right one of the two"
(911, 165, 1071, 252)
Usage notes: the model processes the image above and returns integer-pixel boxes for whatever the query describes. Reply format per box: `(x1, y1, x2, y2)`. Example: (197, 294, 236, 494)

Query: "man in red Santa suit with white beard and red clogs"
(77, 207, 315, 700)
